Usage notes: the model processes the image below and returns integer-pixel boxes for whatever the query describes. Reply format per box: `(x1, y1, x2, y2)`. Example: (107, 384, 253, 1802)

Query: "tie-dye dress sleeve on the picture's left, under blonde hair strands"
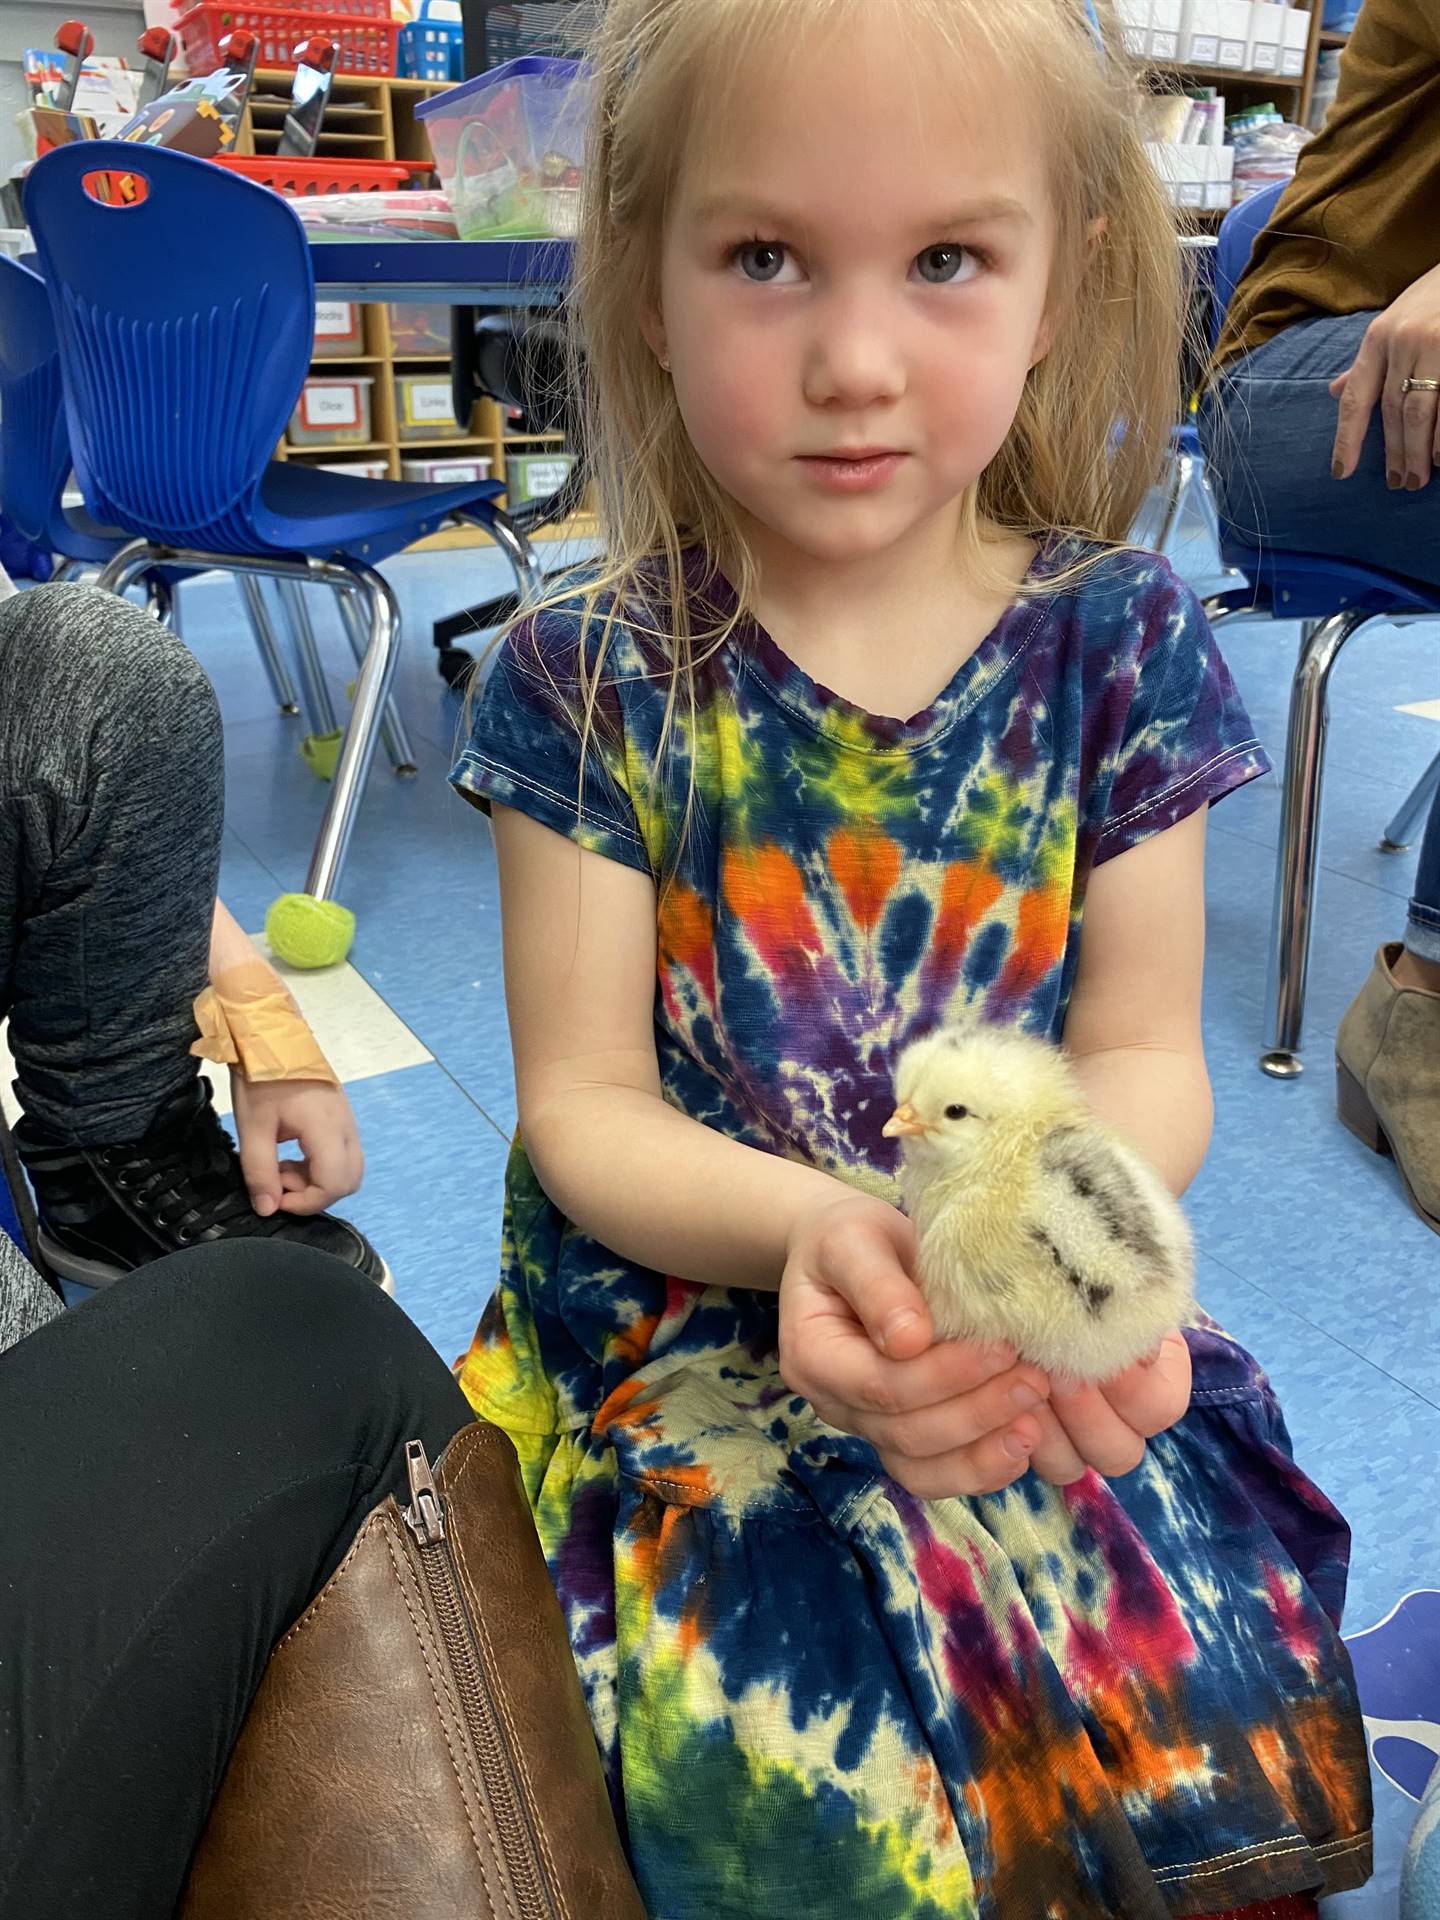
(449, 607, 651, 872)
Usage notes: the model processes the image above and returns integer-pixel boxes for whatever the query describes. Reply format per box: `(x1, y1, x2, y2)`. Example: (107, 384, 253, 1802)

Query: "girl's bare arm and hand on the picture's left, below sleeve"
(493, 806, 1048, 1498)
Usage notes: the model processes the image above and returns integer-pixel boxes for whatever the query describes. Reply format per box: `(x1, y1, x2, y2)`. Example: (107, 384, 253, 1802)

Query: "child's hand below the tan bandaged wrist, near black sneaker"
(230, 1068, 365, 1219)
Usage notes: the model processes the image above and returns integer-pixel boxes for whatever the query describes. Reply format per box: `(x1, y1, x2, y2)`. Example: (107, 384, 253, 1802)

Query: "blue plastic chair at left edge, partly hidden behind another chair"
(0, 255, 314, 714)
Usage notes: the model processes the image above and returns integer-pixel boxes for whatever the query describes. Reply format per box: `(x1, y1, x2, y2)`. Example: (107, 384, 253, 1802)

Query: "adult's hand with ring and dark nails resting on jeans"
(1331, 267, 1440, 492)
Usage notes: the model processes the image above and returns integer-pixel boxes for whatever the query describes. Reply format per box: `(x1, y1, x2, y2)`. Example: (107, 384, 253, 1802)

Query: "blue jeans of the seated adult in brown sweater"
(1200, 313, 1440, 962)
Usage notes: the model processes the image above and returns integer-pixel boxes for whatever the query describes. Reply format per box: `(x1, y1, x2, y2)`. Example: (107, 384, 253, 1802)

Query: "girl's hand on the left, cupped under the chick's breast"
(780, 1194, 1048, 1500)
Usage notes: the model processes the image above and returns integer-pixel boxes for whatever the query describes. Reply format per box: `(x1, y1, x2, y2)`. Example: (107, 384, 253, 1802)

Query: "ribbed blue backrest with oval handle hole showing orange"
(25, 140, 315, 551)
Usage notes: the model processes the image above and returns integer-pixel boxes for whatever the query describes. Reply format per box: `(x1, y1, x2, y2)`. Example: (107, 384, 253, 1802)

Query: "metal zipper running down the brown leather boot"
(405, 1440, 555, 1920)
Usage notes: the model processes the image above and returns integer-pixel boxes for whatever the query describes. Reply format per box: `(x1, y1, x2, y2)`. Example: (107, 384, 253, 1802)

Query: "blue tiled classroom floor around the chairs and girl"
(166, 518, 1440, 1920)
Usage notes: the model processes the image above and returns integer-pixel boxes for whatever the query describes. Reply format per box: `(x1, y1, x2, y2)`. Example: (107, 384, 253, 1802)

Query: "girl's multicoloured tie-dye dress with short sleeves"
(453, 543, 1369, 1920)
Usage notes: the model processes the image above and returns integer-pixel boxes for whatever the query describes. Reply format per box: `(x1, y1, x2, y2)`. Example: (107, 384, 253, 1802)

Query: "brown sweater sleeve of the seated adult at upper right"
(1215, 0, 1440, 363)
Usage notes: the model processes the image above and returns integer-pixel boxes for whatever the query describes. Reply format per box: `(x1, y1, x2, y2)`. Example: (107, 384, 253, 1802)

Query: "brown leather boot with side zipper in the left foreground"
(179, 1423, 645, 1920)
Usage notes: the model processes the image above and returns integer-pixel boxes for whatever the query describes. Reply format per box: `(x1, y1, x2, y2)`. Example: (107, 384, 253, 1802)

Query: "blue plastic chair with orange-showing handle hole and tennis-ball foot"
(25, 140, 538, 899)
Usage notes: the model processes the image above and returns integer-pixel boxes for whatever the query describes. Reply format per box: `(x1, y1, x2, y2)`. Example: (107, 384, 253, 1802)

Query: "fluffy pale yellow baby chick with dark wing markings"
(883, 1027, 1194, 1380)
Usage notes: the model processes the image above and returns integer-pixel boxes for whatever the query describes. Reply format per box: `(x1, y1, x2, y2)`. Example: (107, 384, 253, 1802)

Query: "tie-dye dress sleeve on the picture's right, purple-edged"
(1094, 566, 1269, 866)
